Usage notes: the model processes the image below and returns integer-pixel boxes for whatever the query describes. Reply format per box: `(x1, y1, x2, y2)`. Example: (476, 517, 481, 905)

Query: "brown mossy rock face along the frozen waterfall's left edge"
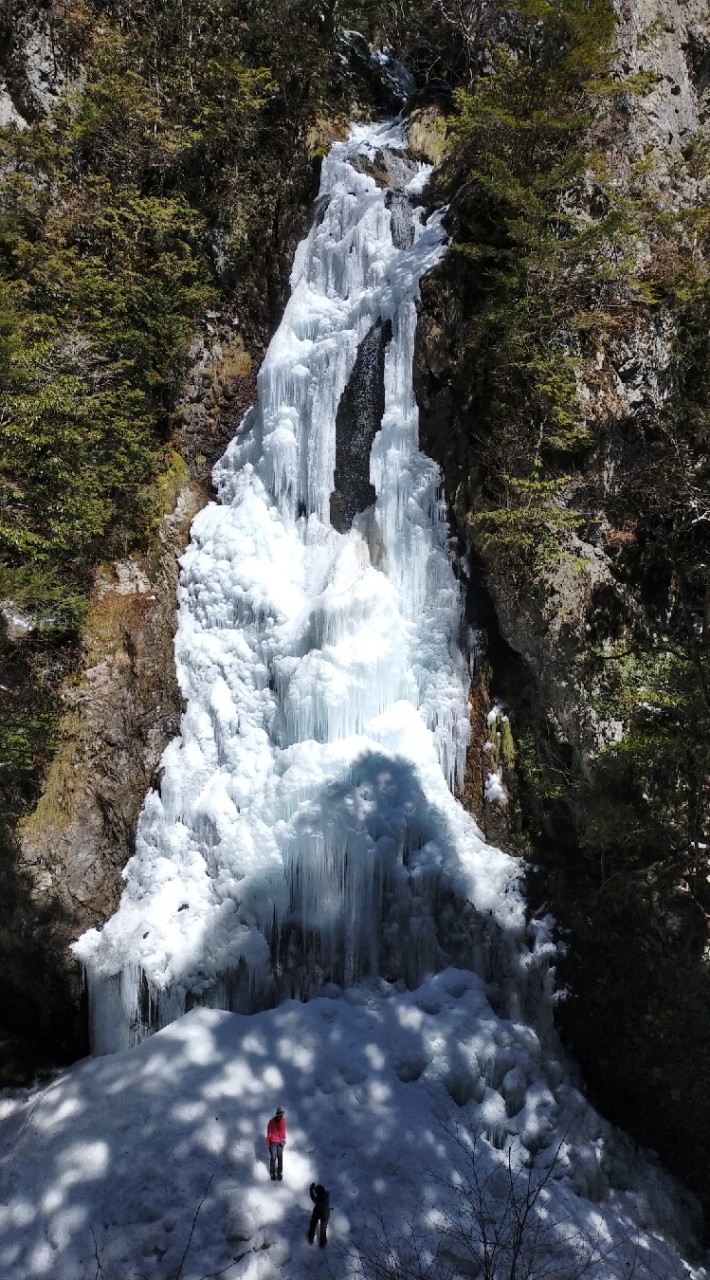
(19, 311, 268, 916)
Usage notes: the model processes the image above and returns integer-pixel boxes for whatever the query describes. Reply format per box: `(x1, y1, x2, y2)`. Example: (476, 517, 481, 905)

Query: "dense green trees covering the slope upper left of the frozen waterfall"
(0, 0, 378, 629)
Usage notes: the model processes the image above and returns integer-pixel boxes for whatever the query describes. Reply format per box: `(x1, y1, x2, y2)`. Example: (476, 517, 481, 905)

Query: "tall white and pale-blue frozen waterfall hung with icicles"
(75, 124, 539, 1052)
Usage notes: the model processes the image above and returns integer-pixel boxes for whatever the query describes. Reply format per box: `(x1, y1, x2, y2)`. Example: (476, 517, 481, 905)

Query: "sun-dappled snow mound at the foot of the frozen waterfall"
(0, 969, 705, 1280)
